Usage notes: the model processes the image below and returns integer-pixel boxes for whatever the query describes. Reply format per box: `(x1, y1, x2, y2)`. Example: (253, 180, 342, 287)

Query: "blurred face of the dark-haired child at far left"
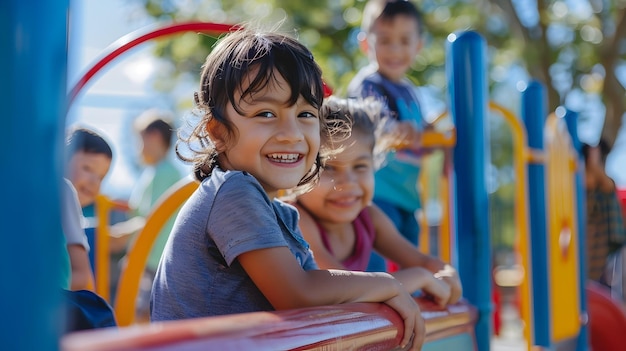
(67, 151, 111, 207)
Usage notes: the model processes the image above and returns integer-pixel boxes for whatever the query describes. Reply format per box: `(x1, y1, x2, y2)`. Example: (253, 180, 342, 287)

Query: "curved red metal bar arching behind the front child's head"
(67, 22, 237, 106)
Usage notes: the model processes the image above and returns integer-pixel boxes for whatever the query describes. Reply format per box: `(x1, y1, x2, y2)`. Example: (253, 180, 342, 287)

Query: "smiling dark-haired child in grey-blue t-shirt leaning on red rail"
(151, 28, 424, 350)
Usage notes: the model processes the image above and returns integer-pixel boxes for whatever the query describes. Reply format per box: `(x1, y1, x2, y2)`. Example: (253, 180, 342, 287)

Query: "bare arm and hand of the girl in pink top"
(368, 205, 463, 303)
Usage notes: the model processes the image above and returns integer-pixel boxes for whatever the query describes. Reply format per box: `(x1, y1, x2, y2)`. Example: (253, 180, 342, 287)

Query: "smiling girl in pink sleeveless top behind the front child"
(296, 96, 462, 306)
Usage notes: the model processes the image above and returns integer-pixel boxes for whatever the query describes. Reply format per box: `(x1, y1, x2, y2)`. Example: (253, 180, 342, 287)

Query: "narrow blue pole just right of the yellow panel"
(564, 111, 589, 351)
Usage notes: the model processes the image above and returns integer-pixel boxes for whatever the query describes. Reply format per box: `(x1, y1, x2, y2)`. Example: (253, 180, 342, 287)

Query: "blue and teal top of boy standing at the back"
(348, 65, 424, 212)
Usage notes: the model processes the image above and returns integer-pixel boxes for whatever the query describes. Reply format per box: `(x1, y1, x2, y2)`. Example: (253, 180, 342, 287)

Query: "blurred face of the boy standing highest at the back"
(368, 15, 422, 81)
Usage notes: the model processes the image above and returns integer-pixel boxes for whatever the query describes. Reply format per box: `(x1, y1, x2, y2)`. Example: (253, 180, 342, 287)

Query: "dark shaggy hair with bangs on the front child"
(176, 27, 342, 191)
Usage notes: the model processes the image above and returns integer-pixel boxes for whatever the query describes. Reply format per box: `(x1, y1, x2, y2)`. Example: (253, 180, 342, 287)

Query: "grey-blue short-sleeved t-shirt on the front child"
(150, 168, 317, 321)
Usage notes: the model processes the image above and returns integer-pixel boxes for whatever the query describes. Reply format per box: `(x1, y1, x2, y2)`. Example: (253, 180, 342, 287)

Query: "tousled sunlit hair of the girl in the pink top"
(321, 96, 397, 167)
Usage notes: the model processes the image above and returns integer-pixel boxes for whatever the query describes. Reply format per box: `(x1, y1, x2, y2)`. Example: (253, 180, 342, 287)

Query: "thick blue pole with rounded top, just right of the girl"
(446, 31, 493, 351)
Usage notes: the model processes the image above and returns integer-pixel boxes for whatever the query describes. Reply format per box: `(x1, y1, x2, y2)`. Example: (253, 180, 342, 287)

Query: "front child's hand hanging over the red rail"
(385, 288, 426, 351)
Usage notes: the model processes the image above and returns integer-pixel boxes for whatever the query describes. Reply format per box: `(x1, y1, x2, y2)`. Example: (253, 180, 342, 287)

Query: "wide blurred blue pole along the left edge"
(0, 0, 69, 350)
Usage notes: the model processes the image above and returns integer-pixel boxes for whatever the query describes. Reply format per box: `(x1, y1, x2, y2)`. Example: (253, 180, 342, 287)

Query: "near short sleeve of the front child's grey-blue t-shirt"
(207, 173, 288, 265)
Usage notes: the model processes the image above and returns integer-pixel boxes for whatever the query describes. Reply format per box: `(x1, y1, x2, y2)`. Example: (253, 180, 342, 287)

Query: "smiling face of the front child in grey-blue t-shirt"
(216, 72, 320, 198)
